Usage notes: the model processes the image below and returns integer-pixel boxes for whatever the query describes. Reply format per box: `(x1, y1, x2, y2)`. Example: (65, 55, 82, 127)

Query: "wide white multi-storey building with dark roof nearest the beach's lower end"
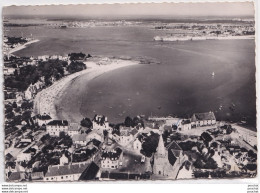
(46, 120, 69, 136)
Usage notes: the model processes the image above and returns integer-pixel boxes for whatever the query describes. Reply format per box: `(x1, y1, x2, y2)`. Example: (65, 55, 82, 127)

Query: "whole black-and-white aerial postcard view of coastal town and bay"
(2, 2, 258, 182)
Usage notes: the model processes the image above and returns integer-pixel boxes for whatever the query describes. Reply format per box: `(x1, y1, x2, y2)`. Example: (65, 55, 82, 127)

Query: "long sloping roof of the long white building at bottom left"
(45, 163, 89, 177)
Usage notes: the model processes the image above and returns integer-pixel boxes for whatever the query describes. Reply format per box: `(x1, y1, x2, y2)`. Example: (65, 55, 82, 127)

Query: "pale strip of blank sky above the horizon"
(3, 2, 254, 17)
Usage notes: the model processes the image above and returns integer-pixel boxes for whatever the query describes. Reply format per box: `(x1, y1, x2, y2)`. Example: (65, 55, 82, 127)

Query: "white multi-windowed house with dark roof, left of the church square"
(101, 147, 123, 169)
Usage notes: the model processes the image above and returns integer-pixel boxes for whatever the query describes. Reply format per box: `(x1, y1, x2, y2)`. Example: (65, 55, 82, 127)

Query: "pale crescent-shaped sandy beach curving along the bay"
(34, 58, 140, 121)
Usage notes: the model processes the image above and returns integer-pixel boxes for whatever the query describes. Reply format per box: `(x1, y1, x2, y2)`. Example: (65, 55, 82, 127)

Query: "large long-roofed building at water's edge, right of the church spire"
(191, 111, 216, 127)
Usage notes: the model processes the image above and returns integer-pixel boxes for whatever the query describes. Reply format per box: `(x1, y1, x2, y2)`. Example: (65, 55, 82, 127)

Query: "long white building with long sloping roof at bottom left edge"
(44, 163, 89, 181)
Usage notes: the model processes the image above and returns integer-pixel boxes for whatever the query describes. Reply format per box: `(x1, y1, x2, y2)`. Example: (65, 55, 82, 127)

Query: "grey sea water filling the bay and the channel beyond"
(5, 27, 256, 126)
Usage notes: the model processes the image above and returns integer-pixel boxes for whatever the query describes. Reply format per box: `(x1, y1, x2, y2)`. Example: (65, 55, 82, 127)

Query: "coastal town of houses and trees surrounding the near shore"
(4, 35, 257, 182)
